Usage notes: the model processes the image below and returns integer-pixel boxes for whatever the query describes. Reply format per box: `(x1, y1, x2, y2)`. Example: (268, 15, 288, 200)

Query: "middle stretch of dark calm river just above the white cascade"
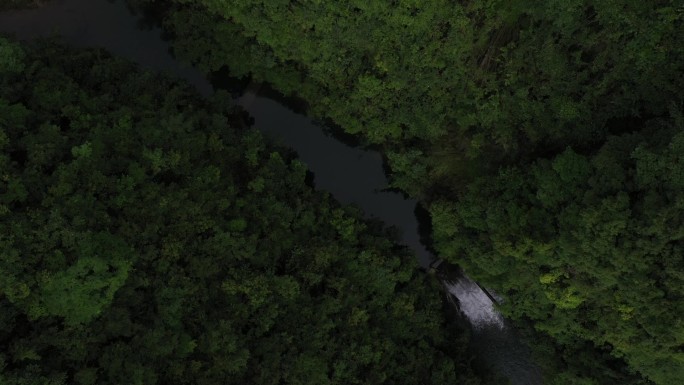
(238, 87, 434, 268)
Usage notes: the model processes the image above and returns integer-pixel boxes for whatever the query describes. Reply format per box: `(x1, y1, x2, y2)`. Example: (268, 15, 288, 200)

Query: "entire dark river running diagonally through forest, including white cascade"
(0, 0, 542, 385)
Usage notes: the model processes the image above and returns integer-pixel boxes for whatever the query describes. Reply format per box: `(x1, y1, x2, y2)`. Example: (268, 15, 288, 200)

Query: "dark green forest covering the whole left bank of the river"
(0, 39, 480, 385)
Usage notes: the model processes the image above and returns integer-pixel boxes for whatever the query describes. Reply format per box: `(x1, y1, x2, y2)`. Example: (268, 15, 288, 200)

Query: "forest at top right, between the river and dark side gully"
(131, 0, 684, 193)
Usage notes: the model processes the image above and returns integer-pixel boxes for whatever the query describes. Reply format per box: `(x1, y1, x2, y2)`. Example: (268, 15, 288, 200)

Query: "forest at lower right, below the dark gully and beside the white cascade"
(431, 112, 684, 384)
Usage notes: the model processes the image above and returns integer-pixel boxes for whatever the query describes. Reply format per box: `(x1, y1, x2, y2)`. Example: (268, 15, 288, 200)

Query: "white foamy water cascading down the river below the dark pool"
(444, 275, 505, 330)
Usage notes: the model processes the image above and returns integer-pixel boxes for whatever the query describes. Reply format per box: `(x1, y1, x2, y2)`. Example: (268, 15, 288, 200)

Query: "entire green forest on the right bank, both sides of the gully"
(123, 0, 684, 385)
